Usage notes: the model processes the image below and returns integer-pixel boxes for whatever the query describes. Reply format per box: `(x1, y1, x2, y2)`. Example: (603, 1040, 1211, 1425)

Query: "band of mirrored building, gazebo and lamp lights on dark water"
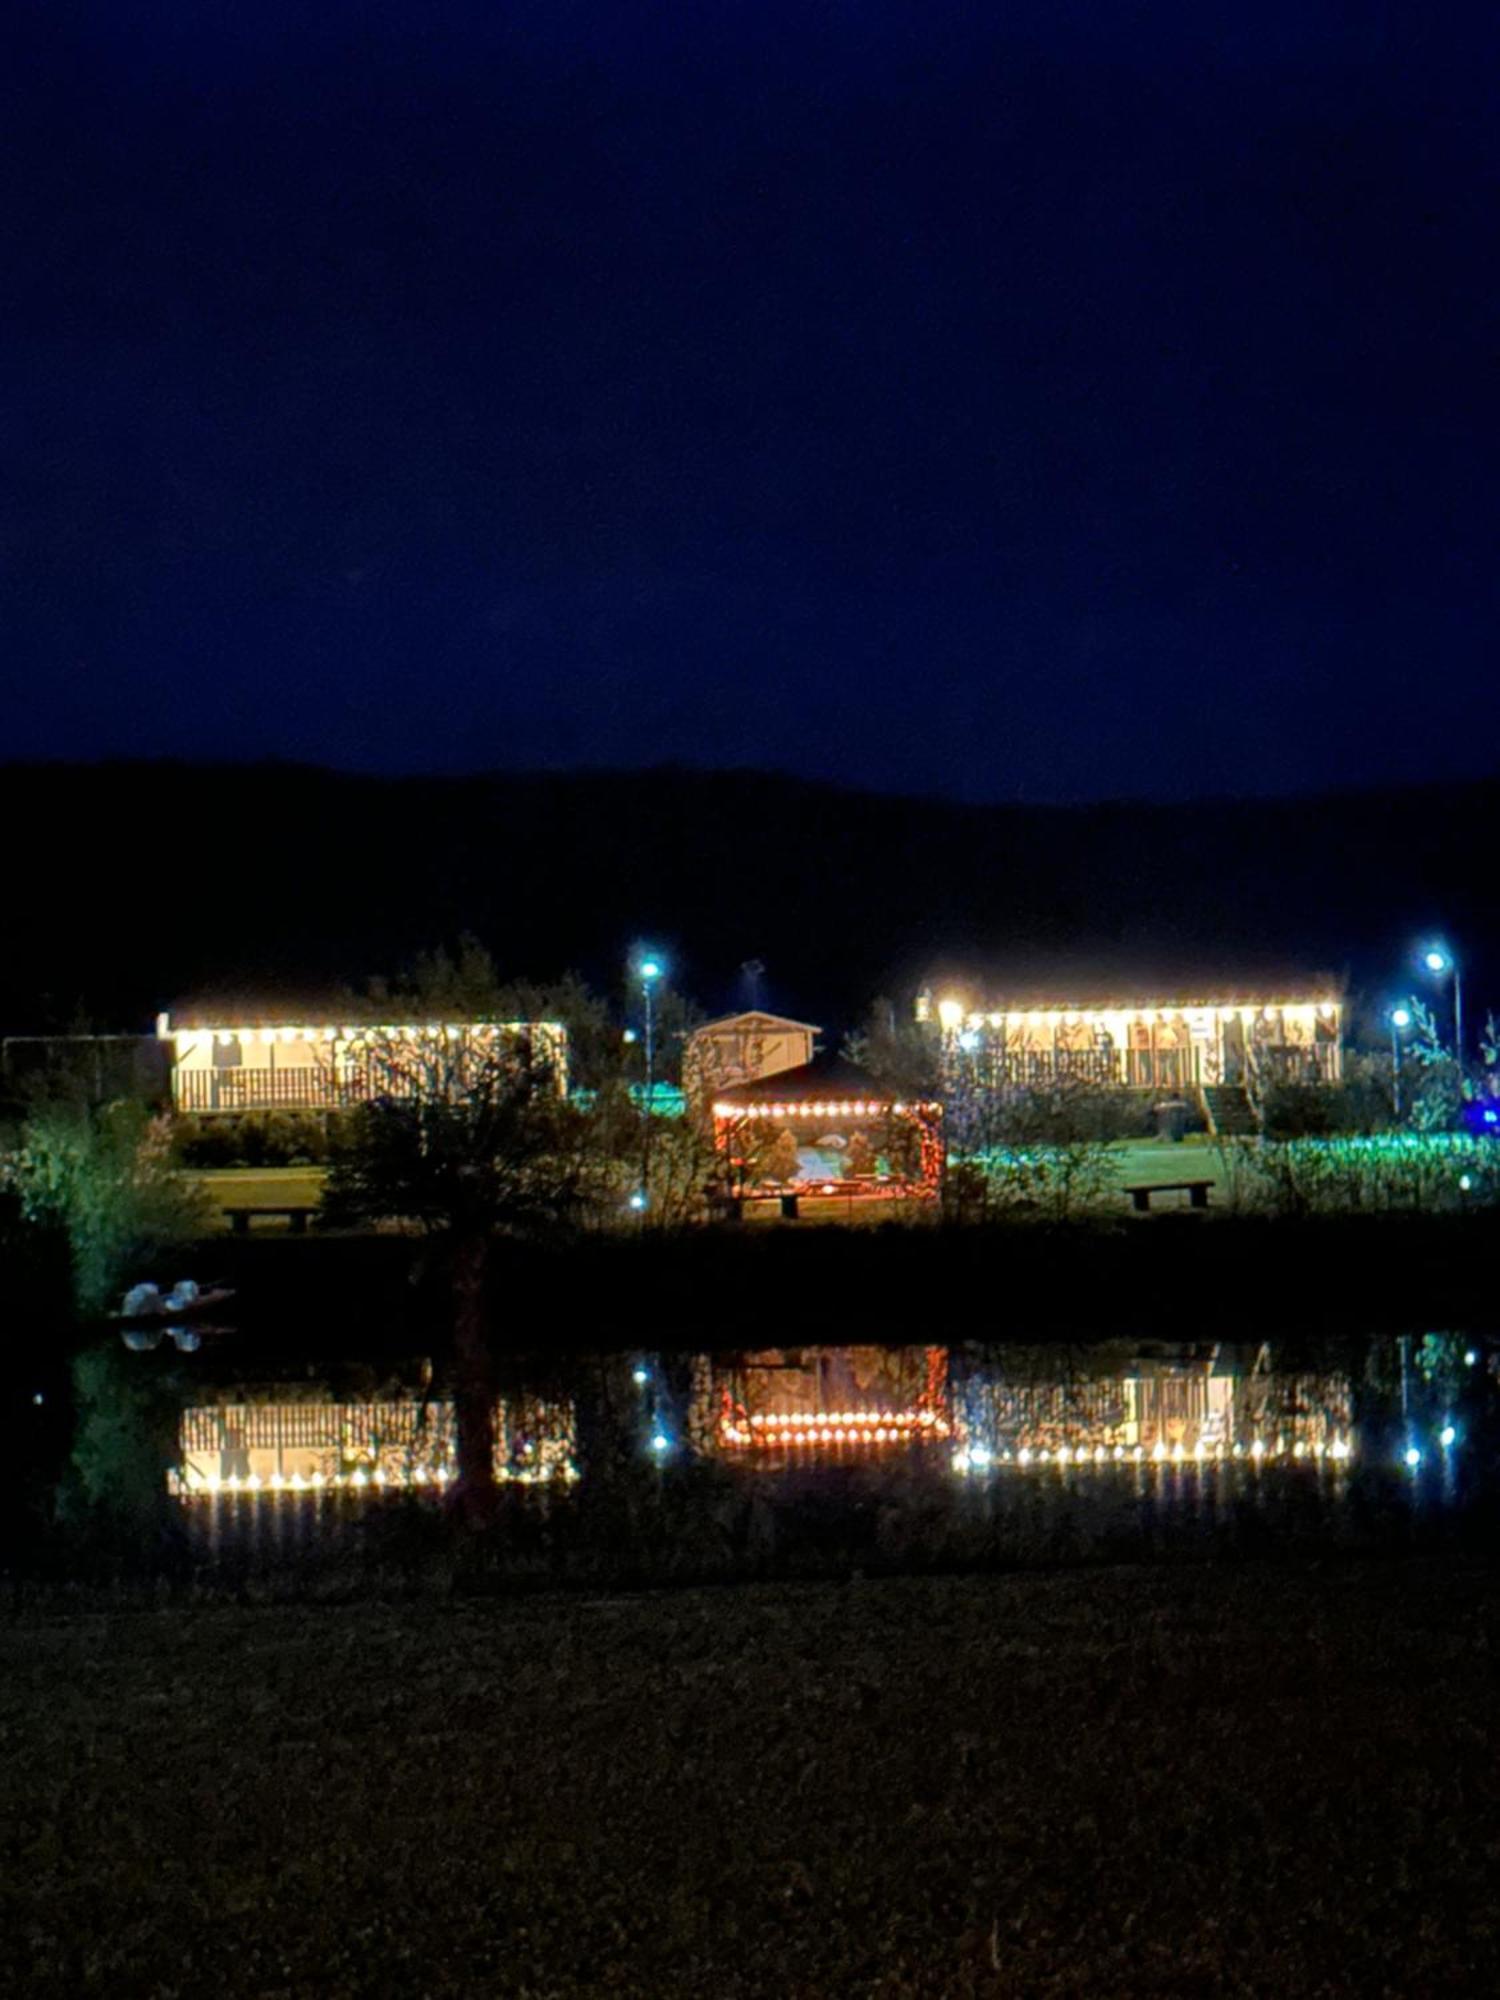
(159, 1334, 1494, 1500)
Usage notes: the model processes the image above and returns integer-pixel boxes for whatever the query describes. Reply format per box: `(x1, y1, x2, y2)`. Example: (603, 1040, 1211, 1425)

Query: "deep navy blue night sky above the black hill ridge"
(0, 0, 1500, 800)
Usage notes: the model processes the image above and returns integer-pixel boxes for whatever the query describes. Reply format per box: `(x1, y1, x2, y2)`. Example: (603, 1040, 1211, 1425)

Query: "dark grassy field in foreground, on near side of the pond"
(0, 1560, 1500, 2000)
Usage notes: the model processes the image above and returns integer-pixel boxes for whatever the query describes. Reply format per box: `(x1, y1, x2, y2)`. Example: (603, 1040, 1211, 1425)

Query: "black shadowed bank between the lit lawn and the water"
(194, 1214, 1500, 1354)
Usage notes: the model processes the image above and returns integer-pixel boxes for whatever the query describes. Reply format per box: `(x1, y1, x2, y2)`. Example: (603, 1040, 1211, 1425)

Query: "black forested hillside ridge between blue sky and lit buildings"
(0, 764, 1500, 1032)
